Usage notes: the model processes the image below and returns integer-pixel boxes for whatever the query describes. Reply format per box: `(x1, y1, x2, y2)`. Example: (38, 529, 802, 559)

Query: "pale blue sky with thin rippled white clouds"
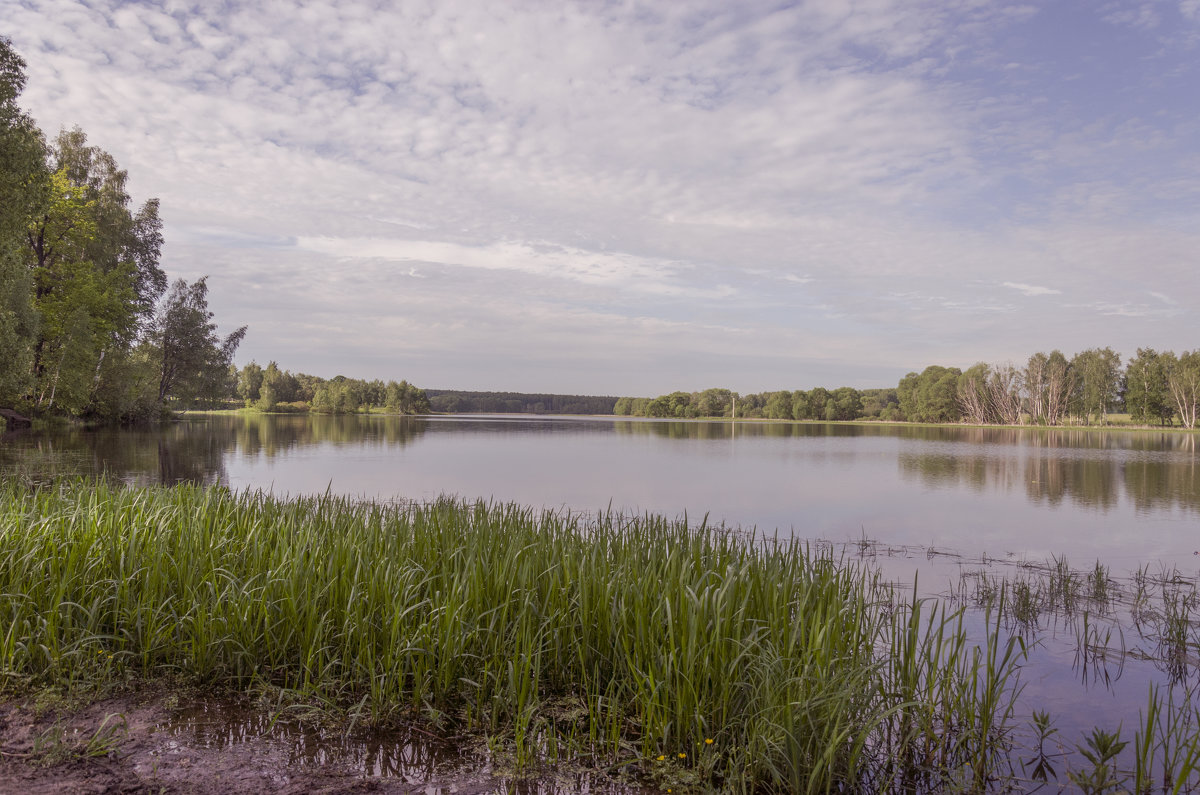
(0, 0, 1200, 396)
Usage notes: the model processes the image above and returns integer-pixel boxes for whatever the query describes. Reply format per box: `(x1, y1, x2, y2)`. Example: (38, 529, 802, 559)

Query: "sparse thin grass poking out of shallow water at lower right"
(950, 557, 1200, 794)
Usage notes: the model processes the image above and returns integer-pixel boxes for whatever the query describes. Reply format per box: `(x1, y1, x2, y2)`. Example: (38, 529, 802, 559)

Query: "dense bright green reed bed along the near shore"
(0, 483, 1022, 791)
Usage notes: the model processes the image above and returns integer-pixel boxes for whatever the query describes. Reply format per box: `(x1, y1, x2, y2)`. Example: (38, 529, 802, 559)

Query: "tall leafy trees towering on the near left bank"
(0, 38, 246, 420)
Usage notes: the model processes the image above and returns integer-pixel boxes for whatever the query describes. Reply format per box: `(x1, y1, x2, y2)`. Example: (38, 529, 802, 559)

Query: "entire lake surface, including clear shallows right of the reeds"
(7, 414, 1200, 783)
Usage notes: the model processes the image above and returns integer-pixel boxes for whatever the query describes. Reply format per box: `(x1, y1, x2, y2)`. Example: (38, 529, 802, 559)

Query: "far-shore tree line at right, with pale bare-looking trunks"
(613, 348, 1200, 429)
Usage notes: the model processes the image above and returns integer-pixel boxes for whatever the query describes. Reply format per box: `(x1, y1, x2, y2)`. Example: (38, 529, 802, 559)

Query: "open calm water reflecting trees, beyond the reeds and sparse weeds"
(0, 416, 1200, 572)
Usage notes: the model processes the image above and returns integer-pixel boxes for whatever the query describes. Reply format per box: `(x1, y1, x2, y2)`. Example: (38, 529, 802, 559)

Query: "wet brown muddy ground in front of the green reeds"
(0, 686, 644, 795)
